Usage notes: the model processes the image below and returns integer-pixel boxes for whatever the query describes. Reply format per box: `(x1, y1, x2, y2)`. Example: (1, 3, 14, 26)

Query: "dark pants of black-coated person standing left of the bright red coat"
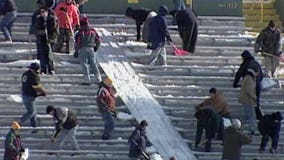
(37, 38, 54, 74)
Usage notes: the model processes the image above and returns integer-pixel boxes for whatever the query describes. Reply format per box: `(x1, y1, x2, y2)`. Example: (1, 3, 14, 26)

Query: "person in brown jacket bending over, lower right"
(195, 88, 231, 140)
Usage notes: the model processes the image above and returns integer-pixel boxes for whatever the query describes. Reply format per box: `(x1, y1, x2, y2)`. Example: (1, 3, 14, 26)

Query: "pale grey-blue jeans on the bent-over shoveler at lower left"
(56, 125, 80, 150)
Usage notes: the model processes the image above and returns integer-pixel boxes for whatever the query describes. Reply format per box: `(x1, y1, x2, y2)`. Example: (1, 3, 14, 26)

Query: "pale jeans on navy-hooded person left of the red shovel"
(150, 46, 167, 65)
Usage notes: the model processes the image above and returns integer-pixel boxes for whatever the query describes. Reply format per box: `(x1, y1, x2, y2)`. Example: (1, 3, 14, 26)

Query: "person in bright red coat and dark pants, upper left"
(54, 0, 80, 54)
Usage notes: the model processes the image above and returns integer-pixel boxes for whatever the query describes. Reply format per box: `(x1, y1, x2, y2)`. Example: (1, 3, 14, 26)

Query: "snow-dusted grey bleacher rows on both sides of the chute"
(0, 13, 284, 160)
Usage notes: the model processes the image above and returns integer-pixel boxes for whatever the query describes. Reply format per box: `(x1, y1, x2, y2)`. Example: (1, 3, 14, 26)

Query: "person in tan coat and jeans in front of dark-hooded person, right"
(239, 69, 257, 135)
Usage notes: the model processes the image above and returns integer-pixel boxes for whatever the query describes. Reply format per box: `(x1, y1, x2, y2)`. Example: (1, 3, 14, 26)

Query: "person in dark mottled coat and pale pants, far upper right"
(254, 20, 282, 77)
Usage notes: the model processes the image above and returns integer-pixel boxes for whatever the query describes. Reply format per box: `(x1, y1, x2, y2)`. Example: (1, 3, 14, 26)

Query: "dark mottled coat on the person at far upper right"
(255, 27, 282, 56)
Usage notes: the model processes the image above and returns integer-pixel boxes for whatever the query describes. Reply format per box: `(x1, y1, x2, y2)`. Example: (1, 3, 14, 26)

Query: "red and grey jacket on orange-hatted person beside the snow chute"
(96, 83, 115, 113)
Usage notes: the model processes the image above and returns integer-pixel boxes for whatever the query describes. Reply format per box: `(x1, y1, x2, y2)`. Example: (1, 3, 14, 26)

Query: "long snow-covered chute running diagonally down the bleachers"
(98, 30, 196, 160)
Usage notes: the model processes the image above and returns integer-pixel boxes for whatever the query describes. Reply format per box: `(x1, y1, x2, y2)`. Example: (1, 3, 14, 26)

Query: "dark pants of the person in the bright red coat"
(55, 28, 72, 53)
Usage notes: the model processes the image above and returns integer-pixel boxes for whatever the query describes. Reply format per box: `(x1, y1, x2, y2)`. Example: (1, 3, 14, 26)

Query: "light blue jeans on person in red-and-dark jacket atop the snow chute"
(78, 47, 101, 82)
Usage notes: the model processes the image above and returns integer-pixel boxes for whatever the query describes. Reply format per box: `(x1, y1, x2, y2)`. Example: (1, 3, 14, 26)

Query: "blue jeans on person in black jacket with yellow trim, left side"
(20, 95, 37, 127)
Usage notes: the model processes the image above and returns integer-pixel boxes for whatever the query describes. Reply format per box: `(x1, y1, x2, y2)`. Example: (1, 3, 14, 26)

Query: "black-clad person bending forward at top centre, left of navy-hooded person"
(125, 7, 151, 41)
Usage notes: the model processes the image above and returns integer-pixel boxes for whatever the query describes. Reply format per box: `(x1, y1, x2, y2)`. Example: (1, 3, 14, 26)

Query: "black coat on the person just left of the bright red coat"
(30, 9, 58, 43)
